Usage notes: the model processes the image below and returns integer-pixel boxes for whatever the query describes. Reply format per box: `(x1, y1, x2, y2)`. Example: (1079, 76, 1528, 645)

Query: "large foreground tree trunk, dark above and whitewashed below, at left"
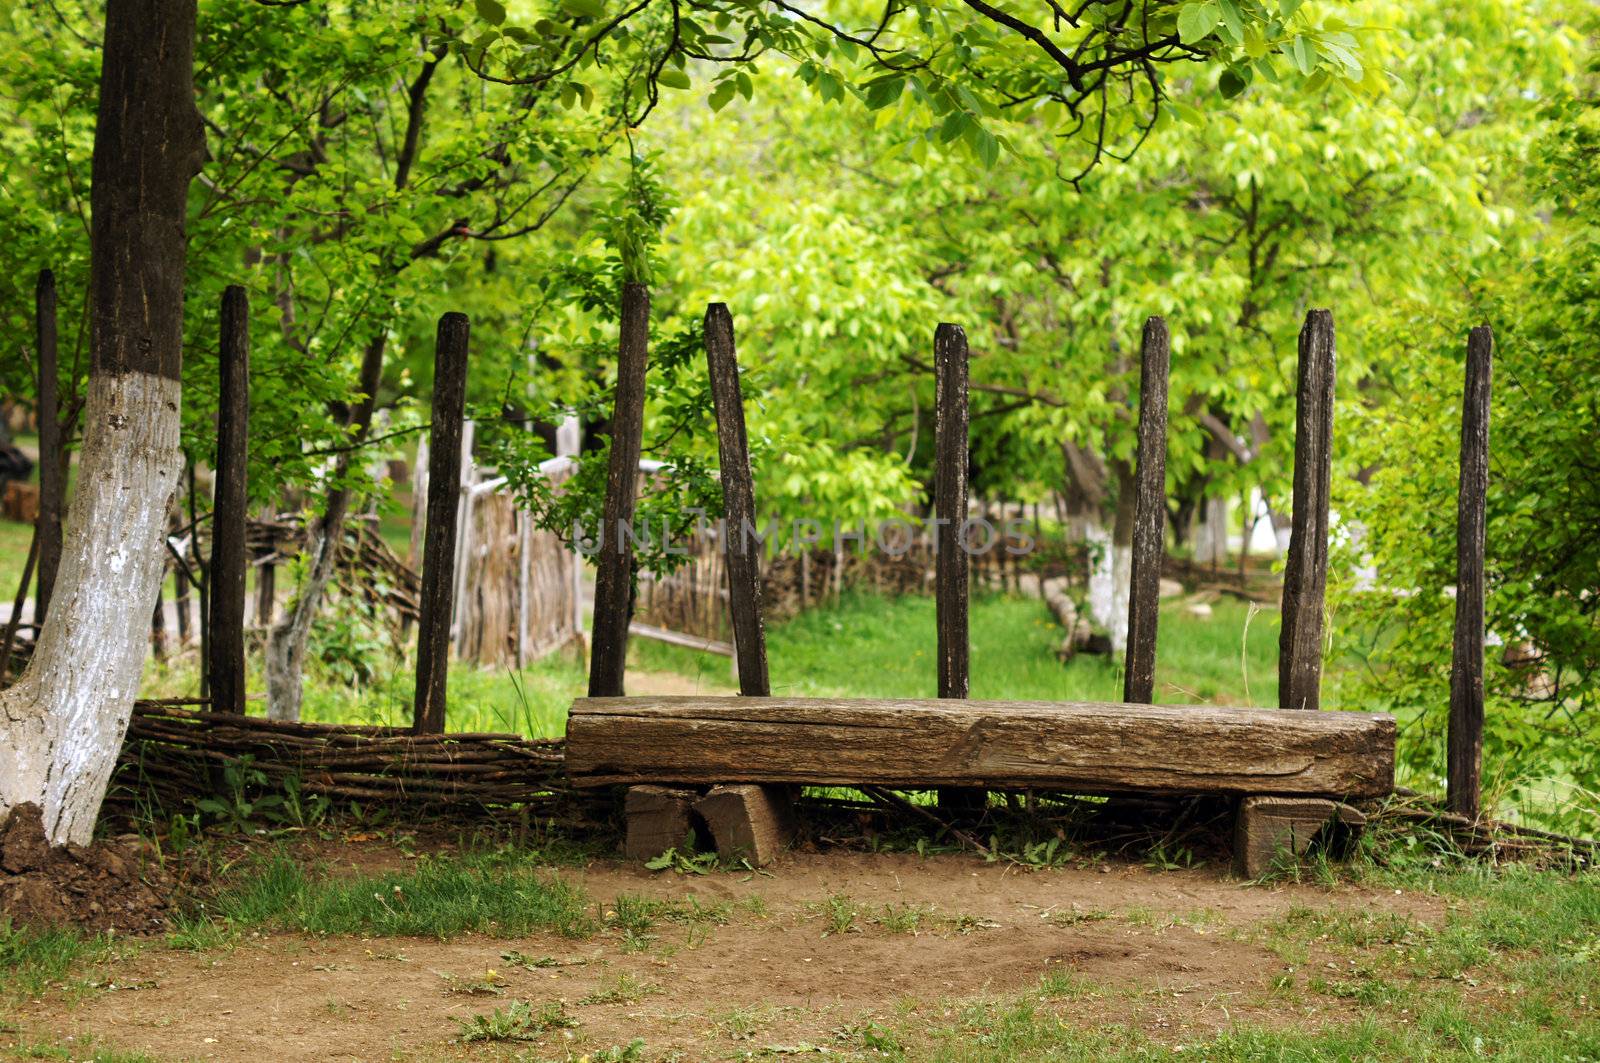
(0, 0, 205, 844)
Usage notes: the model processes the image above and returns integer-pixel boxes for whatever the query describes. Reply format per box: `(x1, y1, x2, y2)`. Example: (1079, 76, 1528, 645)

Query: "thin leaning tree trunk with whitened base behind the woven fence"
(267, 333, 387, 720)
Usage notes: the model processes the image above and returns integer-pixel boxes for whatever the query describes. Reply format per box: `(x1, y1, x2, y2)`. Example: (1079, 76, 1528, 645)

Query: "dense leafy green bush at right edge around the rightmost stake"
(1338, 60, 1600, 832)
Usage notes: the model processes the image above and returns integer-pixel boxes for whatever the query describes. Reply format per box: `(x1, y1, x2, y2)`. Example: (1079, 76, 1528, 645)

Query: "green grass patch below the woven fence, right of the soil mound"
(171, 848, 598, 948)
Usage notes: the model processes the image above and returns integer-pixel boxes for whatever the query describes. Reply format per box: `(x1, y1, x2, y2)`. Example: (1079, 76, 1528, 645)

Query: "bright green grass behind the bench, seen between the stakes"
(634, 594, 1278, 704)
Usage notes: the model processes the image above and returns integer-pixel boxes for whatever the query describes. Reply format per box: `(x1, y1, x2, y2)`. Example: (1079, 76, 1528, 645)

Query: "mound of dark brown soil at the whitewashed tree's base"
(0, 804, 173, 933)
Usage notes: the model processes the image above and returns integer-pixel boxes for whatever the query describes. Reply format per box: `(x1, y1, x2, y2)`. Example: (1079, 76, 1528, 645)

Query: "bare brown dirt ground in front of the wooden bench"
(9, 850, 1443, 1061)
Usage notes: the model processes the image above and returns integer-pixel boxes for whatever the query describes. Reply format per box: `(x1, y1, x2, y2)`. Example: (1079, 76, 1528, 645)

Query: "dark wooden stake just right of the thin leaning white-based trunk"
(411, 314, 469, 735)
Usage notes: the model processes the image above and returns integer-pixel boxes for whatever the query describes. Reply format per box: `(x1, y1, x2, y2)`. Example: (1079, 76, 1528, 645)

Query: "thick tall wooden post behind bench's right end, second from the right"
(1278, 311, 1334, 709)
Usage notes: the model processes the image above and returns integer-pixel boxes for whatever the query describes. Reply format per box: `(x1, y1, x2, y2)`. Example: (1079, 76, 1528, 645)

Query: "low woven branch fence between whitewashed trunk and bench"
(107, 701, 608, 828)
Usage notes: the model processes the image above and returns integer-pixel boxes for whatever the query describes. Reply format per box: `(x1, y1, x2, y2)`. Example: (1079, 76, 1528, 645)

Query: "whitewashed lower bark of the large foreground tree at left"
(0, 371, 182, 845)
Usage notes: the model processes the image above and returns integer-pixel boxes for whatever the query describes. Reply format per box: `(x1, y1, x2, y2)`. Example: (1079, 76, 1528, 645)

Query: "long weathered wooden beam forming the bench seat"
(566, 696, 1395, 797)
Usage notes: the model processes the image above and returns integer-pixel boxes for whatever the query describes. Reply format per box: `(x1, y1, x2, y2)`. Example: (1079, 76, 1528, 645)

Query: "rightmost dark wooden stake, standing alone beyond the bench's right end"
(1446, 325, 1494, 820)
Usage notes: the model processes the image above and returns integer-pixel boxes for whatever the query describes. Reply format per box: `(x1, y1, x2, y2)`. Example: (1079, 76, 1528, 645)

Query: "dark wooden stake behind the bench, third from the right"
(1122, 317, 1171, 704)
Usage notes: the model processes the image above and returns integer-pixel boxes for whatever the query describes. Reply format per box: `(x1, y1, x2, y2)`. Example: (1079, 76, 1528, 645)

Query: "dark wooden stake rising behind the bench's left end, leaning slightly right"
(589, 283, 650, 698)
